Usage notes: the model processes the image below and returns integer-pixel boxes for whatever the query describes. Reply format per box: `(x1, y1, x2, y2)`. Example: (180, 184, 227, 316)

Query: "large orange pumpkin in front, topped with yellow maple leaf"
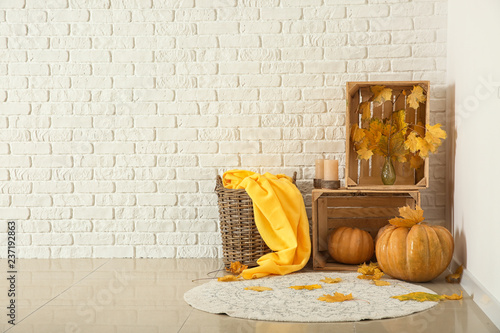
(376, 223, 454, 282)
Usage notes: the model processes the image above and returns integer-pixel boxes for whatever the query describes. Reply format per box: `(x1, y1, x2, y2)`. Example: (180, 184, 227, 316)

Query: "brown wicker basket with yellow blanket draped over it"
(215, 172, 297, 267)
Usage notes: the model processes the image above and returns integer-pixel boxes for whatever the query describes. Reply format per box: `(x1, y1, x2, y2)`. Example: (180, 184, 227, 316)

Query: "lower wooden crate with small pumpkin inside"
(312, 188, 420, 271)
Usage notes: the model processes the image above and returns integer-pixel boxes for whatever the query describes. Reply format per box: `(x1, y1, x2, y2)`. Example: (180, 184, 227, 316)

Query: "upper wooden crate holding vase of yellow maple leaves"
(345, 81, 429, 190)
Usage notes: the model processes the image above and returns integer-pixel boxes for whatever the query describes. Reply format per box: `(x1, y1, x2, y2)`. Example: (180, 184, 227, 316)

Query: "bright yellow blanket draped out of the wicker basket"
(223, 170, 311, 279)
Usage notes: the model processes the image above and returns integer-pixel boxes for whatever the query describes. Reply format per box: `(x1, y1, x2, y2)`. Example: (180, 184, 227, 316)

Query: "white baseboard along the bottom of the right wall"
(450, 258, 500, 329)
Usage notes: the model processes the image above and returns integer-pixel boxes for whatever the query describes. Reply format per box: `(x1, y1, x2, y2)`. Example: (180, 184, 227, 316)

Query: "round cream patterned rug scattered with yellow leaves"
(184, 272, 437, 322)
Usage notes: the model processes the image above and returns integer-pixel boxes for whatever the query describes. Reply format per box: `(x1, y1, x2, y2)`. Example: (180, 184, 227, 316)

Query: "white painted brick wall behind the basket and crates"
(0, 0, 447, 258)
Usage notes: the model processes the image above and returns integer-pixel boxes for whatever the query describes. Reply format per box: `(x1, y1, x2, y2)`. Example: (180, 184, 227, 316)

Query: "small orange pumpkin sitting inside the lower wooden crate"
(328, 227, 375, 264)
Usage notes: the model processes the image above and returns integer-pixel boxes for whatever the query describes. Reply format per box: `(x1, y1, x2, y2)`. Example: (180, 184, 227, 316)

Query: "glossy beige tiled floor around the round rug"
(0, 259, 500, 333)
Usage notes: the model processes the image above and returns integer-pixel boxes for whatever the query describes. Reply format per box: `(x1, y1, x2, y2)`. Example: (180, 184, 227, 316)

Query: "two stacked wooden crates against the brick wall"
(312, 81, 429, 270)
